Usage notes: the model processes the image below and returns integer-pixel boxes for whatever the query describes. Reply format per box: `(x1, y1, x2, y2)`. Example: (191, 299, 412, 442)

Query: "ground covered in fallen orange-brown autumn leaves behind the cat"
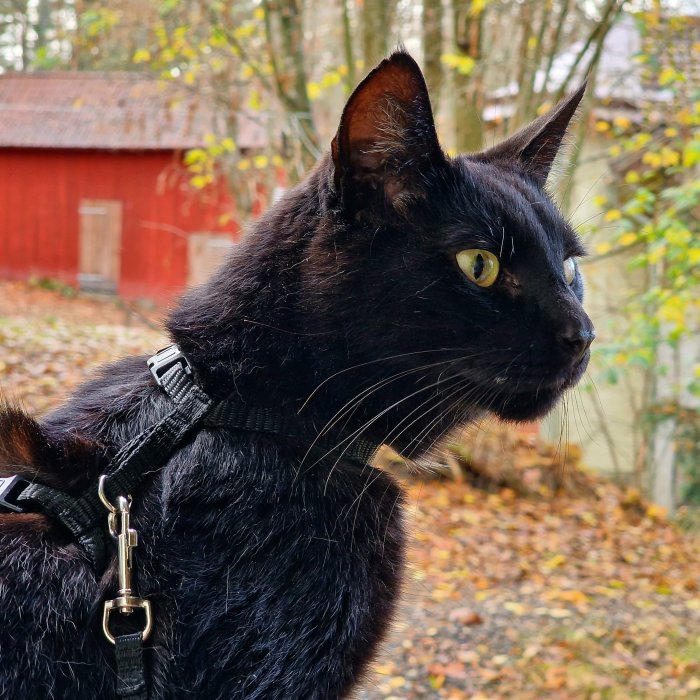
(0, 283, 700, 700)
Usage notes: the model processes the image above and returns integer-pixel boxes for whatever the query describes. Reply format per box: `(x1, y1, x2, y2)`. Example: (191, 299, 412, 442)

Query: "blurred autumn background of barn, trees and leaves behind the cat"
(0, 0, 700, 698)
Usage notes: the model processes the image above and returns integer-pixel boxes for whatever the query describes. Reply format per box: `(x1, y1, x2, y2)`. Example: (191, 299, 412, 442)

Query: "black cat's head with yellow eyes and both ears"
(312, 52, 594, 432)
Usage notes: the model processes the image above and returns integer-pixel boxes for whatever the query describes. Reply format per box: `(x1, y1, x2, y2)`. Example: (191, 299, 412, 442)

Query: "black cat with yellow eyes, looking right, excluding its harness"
(0, 52, 593, 700)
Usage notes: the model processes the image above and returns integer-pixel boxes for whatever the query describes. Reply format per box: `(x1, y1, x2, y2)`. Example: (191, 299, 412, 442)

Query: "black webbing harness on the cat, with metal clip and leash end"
(0, 345, 377, 700)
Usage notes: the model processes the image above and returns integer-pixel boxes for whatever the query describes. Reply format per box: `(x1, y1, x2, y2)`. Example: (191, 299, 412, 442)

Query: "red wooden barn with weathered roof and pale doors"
(0, 72, 259, 302)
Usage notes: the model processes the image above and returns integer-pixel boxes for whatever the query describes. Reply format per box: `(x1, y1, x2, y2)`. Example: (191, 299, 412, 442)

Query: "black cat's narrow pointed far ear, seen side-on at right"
(475, 82, 586, 185)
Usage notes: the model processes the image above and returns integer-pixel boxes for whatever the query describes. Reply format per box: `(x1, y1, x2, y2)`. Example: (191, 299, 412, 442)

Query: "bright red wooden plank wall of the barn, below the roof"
(0, 149, 240, 301)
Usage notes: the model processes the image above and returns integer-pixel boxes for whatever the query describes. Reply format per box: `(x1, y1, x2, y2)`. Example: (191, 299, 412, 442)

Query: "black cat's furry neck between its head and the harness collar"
(168, 162, 470, 460)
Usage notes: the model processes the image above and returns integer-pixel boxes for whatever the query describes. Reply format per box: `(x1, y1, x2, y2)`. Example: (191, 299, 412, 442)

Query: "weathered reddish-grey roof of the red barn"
(0, 71, 264, 150)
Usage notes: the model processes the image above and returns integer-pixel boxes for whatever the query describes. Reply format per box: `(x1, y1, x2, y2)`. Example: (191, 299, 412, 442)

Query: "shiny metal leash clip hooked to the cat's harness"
(97, 474, 153, 644)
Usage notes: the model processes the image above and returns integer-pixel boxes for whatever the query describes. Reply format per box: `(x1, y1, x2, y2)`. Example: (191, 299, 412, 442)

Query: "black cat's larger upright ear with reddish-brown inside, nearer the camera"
(331, 51, 445, 211)
